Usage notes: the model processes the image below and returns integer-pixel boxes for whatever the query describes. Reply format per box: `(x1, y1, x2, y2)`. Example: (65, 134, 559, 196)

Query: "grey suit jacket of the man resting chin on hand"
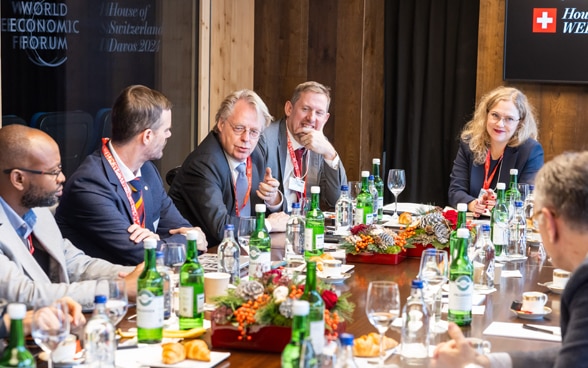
(261, 119, 347, 211)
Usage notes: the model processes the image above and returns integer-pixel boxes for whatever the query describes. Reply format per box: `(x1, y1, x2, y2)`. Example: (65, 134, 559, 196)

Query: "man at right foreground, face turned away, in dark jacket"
(431, 151, 588, 368)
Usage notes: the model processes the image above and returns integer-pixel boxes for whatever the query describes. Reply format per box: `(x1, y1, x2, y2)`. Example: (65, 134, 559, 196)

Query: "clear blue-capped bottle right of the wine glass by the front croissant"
(401, 280, 430, 366)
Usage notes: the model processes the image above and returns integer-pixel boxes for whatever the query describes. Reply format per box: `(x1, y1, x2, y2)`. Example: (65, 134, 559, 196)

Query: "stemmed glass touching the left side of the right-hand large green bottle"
(418, 249, 449, 333)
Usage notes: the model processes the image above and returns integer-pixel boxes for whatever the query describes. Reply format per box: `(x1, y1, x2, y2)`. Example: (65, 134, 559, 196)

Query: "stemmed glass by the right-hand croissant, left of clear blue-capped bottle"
(365, 281, 400, 367)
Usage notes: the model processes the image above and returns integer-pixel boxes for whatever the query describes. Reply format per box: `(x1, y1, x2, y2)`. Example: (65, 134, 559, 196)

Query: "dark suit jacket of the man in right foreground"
(509, 260, 588, 368)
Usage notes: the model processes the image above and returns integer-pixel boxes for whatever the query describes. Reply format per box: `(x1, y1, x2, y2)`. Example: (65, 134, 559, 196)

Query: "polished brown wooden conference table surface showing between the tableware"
(119, 234, 560, 368)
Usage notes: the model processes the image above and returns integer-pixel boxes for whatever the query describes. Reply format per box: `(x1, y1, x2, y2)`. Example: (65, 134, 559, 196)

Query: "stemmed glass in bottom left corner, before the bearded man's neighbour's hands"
(31, 300, 70, 368)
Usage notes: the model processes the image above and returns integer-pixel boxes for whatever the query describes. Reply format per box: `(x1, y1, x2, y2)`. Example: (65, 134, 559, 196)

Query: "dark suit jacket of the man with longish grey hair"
(169, 132, 266, 246)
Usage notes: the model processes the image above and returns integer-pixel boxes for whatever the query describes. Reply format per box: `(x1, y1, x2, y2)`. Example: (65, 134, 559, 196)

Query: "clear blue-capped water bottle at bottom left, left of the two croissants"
(84, 295, 116, 368)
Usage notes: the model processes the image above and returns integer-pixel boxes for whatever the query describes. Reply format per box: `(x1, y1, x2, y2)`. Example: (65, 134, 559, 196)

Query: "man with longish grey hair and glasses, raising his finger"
(169, 89, 287, 246)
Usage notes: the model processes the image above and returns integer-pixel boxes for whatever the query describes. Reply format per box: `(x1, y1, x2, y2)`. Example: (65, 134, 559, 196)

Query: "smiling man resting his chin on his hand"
(260, 81, 347, 212)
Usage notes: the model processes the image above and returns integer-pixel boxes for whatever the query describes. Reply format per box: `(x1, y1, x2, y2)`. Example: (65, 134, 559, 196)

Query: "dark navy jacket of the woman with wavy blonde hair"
(449, 139, 543, 207)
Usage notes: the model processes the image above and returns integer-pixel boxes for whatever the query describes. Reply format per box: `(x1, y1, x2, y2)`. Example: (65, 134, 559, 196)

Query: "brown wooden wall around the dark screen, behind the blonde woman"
(476, 0, 588, 161)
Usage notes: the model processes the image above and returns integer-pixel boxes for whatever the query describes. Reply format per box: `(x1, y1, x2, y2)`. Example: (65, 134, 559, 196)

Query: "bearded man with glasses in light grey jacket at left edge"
(0, 125, 143, 307)
